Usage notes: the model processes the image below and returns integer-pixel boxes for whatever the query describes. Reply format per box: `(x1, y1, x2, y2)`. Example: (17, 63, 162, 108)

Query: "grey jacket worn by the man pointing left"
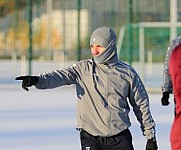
(36, 59, 155, 139)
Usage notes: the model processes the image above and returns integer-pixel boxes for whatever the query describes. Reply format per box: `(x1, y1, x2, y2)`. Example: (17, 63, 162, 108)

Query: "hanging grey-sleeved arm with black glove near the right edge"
(161, 36, 181, 106)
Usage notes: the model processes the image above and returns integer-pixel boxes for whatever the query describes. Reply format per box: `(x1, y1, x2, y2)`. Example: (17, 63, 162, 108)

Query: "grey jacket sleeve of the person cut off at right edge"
(161, 36, 181, 93)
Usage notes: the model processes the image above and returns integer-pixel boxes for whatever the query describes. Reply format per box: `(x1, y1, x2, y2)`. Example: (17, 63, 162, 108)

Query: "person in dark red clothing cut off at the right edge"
(169, 44, 181, 150)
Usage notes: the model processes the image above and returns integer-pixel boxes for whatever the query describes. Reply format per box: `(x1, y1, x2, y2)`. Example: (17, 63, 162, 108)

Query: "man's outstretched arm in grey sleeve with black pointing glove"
(16, 62, 80, 91)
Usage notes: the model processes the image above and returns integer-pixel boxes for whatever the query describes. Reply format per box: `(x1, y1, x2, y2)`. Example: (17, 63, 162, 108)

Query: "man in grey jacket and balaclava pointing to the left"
(16, 27, 157, 150)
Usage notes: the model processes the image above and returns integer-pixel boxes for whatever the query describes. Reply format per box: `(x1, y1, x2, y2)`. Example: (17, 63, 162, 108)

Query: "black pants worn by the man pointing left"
(80, 129, 134, 150)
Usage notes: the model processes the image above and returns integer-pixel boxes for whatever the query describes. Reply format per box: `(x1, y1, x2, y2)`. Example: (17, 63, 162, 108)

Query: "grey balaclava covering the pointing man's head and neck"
(90, 26, 118, 64)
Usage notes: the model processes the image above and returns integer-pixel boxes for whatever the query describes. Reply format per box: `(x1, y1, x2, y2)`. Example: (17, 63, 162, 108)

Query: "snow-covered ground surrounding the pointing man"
(0, 62, 173, 150)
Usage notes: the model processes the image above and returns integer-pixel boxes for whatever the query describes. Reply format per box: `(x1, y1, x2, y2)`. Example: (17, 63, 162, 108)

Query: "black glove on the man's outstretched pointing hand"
(15, 76, 39, 91)
